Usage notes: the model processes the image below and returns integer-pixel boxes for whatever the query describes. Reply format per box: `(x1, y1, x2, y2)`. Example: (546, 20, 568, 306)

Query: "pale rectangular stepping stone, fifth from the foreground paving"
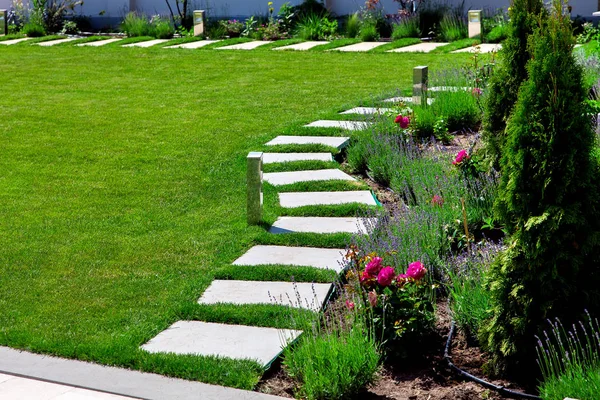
(279, 190, 377, 208)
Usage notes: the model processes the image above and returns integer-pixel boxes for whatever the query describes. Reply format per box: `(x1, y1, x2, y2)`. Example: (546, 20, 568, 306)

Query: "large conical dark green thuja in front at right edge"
(480, 0, 600, 372)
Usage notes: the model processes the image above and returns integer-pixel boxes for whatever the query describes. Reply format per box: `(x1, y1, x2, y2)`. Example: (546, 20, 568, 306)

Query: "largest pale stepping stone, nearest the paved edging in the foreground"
(142, 321, 302, 366)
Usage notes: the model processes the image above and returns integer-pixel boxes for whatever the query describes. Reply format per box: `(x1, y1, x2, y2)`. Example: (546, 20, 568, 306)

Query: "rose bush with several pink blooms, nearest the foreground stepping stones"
(346, 247, 434, 355)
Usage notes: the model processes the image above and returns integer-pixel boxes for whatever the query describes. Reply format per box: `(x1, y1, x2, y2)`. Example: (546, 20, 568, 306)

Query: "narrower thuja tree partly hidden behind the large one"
(483, 0, 546, 168)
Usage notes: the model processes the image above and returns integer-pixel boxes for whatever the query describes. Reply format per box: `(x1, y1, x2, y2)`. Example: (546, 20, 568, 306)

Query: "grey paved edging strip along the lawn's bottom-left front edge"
(0, 347, 281, 400)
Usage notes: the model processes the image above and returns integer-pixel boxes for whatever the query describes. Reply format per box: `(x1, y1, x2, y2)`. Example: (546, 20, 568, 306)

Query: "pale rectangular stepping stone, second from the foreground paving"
(198, 280, 331, 311)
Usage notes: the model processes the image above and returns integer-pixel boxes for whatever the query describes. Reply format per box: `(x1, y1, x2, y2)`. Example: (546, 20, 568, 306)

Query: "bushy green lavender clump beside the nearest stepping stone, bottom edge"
(283, 311, 380, 399)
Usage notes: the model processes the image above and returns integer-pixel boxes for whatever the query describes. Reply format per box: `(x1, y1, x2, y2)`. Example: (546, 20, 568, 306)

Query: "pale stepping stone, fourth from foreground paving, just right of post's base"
(269, 217, 375, 234)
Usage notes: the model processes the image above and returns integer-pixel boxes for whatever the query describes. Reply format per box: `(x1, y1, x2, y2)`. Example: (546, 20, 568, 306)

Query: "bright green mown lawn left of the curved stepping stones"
(0, 44, 469, 389)
